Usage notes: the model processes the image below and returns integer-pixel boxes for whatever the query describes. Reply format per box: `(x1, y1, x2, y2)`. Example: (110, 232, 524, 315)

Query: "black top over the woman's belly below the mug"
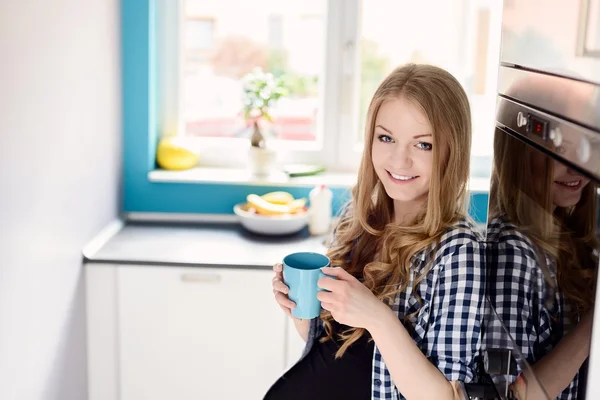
(264, 321, 375, 400)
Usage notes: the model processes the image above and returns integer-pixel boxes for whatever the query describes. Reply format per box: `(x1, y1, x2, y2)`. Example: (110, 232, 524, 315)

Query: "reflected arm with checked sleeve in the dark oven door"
(486, 243, 592, 400)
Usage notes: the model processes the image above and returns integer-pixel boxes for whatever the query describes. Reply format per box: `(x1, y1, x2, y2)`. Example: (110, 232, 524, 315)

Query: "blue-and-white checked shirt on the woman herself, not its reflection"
(304, 221, 485, 400)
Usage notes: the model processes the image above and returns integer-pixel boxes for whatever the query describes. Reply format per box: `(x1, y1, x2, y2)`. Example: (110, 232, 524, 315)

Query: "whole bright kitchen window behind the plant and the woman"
(159, 0, 502, 178)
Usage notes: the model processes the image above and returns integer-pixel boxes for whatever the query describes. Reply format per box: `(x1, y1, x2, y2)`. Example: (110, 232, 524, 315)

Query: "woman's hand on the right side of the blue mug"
(317, 267, 391, 330)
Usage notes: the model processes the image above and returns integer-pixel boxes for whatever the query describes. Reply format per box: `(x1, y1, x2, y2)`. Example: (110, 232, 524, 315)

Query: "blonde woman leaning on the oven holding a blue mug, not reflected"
(265, 64, 484, 400)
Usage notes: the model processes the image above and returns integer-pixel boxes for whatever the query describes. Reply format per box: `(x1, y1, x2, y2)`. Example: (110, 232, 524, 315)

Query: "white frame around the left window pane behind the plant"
(156, 0, 362, 172)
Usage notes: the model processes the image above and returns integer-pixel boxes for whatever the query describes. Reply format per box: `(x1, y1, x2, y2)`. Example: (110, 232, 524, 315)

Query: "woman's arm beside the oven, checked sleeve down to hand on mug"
(317, 237, 484, 400)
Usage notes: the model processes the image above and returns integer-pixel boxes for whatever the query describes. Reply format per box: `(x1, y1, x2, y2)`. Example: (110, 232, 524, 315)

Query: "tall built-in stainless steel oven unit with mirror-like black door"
(482, 0, 600, 399)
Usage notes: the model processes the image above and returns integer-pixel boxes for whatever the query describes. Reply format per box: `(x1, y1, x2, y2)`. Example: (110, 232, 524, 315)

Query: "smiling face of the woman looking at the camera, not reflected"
(371, 97, 433, 210)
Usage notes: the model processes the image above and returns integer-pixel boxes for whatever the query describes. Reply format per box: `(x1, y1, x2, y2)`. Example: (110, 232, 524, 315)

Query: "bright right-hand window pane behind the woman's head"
(355, 0, 502, 178)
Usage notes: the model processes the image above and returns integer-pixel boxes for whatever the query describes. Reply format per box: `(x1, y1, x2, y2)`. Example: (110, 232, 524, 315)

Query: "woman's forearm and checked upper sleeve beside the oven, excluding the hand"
(369, 242, 485, 400)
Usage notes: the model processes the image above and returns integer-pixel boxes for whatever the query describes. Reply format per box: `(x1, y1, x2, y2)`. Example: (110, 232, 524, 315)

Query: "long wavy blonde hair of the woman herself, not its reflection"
(321, 64, 471, 357)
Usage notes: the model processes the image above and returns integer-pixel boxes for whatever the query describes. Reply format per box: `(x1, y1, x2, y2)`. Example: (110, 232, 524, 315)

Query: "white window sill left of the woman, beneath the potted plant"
(148, 167, 356, 189)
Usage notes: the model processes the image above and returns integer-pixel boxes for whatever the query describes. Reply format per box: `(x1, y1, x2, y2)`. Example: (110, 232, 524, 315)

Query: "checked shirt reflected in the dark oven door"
(484, 217, 578, 400)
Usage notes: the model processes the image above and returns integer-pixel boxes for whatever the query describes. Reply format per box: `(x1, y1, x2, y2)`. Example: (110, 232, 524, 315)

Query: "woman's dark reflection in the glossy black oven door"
(486, 76, 598, 400)
